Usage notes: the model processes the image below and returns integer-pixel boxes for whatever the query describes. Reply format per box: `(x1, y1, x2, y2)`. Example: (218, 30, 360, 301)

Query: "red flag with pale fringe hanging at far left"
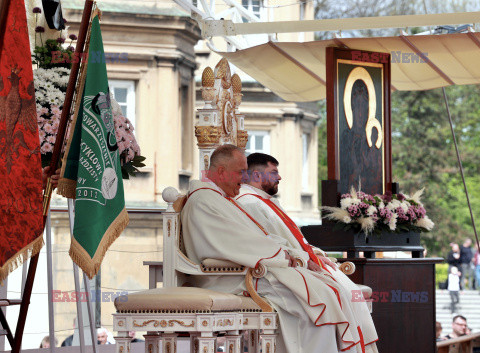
(0, 0, 43, 281)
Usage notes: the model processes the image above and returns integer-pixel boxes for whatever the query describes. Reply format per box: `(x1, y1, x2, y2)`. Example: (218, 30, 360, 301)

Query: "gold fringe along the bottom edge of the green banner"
(69, 208, 129, 279)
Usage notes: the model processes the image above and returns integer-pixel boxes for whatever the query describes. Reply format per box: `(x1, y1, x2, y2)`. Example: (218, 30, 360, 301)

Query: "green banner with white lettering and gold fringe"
(59, 16, 128, 278)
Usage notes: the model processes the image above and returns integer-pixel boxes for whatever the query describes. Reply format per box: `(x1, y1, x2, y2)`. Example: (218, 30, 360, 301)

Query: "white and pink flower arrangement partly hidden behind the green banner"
(27, 0, 145, 179)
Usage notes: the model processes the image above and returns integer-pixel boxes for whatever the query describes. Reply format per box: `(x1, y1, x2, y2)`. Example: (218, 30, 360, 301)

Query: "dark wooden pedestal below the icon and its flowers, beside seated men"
(340, 258, 443, 353)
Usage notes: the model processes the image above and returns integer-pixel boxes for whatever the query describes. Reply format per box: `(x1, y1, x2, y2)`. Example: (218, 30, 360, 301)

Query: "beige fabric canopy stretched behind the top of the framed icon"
(219, 32, 480, 102)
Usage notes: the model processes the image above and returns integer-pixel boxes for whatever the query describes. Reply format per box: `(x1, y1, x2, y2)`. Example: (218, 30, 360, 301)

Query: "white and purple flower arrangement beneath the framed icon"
(322, 187, 434, 234)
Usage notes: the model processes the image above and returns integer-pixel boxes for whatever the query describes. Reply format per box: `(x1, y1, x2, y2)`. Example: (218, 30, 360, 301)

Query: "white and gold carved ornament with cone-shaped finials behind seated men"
(195, 58, 248, 173)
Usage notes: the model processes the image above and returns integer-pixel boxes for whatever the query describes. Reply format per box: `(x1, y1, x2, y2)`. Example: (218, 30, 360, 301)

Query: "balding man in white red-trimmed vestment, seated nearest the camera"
(181, 145, 377, 353)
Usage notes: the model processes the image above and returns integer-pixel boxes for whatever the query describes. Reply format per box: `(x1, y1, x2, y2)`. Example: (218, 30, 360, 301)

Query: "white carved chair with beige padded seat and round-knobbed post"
(113, 187, 278, 353)
